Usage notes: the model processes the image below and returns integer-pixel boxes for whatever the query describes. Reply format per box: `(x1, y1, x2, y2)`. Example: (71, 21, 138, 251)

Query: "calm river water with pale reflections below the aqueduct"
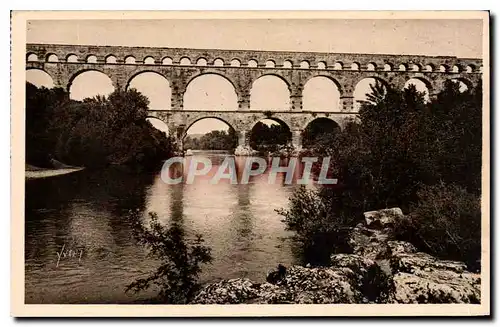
(25, 154, 298, 303)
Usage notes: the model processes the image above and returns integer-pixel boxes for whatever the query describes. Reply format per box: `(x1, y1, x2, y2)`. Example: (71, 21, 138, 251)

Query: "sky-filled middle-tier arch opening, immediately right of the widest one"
(250, 75, 290, 111)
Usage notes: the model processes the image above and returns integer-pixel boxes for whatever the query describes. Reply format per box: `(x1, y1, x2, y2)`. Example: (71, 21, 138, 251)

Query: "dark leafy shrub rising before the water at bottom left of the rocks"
(125, 213, 212, 304)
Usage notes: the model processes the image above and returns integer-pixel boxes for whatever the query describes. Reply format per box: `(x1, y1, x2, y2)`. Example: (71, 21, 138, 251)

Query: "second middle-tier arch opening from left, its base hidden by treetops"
(68, 70, 115, 100)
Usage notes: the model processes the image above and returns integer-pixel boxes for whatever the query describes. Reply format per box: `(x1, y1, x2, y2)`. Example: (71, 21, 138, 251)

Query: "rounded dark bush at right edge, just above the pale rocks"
(395, 183, 481, 270)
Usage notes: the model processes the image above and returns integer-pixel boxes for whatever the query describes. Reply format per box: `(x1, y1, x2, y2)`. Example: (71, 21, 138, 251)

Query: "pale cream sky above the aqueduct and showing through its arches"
(27, 19, 482, 134)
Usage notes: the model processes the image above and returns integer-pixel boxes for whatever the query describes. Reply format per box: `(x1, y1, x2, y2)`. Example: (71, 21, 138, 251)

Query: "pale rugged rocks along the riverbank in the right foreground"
(193, 208, 481, 304)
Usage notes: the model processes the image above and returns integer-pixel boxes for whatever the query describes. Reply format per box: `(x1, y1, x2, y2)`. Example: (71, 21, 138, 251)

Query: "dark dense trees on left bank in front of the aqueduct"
(26, 83, 172, 168)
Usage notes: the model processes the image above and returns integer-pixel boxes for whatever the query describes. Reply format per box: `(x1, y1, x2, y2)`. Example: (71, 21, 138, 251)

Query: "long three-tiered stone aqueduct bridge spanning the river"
(26, 44, 482, 151)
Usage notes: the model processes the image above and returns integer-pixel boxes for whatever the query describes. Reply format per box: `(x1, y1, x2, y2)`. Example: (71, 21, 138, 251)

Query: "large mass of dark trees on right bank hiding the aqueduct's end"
(283, 81, 482, 270)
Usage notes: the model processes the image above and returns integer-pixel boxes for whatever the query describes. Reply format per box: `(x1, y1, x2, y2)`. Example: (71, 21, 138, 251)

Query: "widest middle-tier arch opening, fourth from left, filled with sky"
(184, 73, 238, 111)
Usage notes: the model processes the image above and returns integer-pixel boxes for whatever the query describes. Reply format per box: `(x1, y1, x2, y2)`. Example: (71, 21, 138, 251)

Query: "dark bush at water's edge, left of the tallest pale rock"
(277, 185, 356, 265)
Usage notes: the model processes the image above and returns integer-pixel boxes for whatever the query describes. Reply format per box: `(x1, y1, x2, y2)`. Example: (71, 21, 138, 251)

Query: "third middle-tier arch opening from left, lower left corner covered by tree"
(127, 71, 172, 110)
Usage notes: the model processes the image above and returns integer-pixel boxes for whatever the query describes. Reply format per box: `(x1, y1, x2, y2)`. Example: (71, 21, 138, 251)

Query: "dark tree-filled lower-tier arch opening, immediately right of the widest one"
(250, 118, 292, 153)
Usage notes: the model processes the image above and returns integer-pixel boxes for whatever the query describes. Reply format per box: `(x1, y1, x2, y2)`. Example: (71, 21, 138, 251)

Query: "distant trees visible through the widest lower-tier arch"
(184, 128, 238, 151)
